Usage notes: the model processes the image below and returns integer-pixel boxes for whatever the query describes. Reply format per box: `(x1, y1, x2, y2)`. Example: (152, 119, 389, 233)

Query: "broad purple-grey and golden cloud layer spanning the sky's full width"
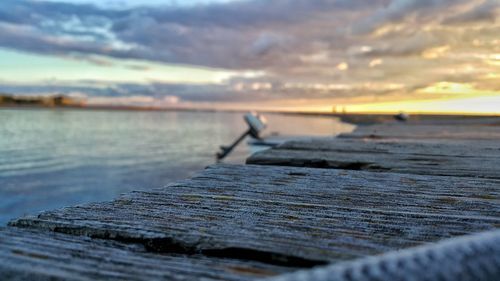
(0, 0, 500, 105)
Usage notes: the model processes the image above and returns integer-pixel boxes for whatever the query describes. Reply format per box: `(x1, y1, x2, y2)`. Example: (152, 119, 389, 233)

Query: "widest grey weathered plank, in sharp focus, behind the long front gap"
(11, 165, 500, 266)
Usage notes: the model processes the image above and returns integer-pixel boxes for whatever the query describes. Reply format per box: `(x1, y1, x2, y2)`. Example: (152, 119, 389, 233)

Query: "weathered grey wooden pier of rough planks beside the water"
(0, 118, 500, 280)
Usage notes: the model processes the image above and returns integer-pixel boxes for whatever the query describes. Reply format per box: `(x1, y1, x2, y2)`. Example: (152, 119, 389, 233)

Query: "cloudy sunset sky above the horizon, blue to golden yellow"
(0, 0, 500, 114)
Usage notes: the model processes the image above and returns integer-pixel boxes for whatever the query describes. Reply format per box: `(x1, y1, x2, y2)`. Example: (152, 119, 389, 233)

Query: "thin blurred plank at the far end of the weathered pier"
(340, 123, 500, 140)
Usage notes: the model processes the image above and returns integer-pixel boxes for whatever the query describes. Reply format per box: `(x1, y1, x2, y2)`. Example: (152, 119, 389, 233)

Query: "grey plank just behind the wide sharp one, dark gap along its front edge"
(247, 139, 500, 179)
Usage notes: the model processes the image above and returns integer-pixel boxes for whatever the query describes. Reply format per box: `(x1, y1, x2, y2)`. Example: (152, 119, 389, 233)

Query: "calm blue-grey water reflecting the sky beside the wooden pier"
(0, 109, 353, 225)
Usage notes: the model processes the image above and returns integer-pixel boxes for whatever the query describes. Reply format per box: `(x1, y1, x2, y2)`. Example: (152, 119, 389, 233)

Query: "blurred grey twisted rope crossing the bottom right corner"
(265, 230, 500, 281)
